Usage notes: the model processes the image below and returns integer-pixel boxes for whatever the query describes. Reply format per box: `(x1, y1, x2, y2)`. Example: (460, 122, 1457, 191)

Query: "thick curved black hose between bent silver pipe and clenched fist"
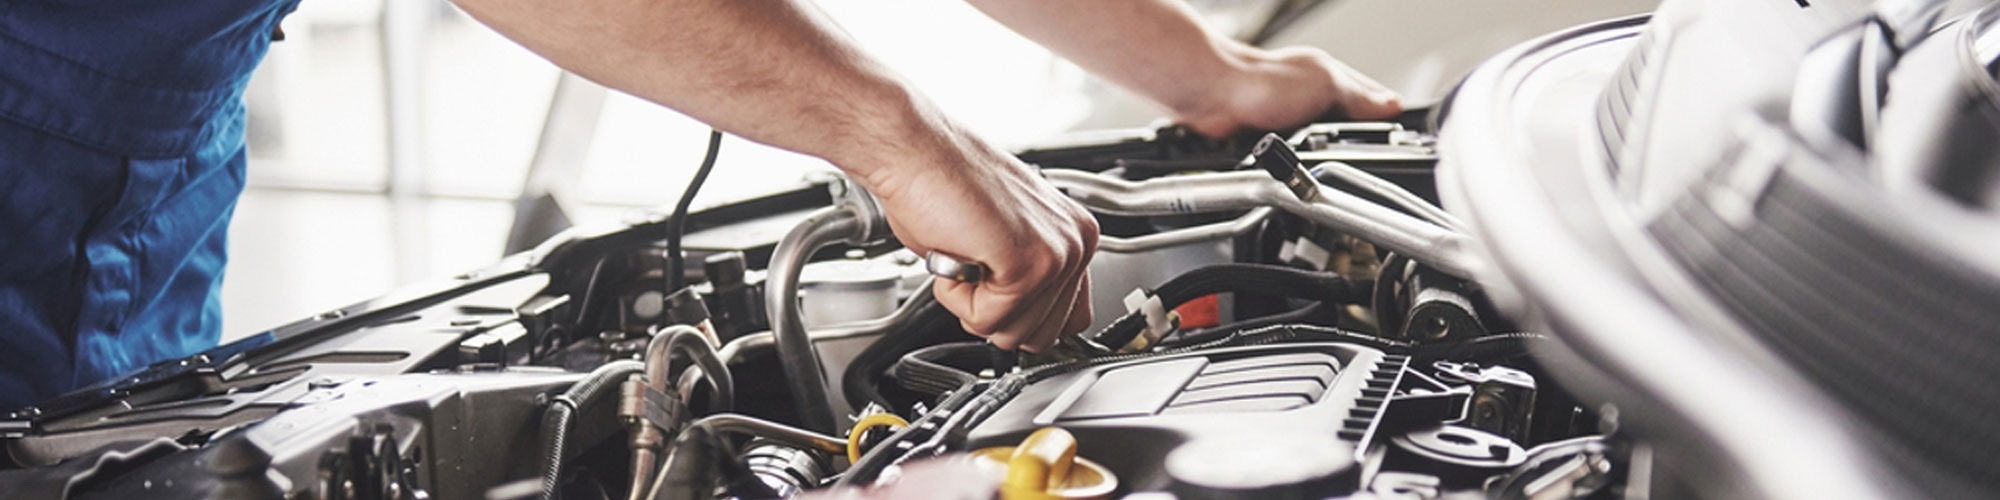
(840, 290, 964, 408)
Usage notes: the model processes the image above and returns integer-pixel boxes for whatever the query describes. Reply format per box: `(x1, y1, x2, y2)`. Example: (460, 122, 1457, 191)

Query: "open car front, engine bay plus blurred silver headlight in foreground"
(0, 0, 2000, 500)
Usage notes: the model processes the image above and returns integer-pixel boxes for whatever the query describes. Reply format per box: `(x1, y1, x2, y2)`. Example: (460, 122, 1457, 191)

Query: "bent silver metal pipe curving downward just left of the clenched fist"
(764, 206, 866, 432)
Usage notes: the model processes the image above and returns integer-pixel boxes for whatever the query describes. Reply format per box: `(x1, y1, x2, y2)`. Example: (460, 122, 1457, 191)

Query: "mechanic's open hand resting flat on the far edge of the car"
(1174, 46, 1402, 138)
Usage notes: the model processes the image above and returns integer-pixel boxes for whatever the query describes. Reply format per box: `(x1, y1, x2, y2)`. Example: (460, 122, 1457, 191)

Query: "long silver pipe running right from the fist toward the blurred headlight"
(1042, 170, 1486, 278)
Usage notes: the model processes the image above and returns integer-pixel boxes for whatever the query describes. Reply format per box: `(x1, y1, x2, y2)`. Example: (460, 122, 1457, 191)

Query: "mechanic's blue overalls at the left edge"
(0, 0, 298, 410)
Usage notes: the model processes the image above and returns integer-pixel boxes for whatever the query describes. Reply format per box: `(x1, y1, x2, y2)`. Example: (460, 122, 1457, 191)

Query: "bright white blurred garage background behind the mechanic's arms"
(224, 0, 1658, 340)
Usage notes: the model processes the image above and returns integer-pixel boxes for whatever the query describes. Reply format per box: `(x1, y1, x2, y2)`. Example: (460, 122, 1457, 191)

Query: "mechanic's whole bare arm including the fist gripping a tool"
(454, 0, 1098, 348)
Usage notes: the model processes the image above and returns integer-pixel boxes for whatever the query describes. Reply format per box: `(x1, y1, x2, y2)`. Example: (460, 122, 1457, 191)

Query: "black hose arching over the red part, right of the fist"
(1090, 264, 1368, 348)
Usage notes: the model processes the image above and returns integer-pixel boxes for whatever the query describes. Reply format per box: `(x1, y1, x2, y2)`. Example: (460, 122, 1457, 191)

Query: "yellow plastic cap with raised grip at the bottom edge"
(972, 428, 1118, 500)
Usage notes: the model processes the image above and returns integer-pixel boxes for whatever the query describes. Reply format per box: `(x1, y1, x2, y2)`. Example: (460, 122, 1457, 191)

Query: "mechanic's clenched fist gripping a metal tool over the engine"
(844, 124, 1098, 350)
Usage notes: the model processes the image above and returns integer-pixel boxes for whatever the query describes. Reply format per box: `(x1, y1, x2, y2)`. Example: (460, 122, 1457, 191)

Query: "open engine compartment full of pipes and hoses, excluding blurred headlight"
(0, 112, 1624, 498)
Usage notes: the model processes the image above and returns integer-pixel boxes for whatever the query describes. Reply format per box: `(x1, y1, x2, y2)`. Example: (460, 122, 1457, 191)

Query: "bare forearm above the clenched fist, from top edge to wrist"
(454, 0, 944, 174)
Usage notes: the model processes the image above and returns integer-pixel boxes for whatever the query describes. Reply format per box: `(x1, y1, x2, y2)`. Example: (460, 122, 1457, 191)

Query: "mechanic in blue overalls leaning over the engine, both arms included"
(0, 0, 1400, 408)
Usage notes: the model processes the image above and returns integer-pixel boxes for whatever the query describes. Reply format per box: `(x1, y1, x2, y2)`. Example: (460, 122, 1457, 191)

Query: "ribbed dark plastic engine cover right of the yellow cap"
(968, 342, 1408, 498)
